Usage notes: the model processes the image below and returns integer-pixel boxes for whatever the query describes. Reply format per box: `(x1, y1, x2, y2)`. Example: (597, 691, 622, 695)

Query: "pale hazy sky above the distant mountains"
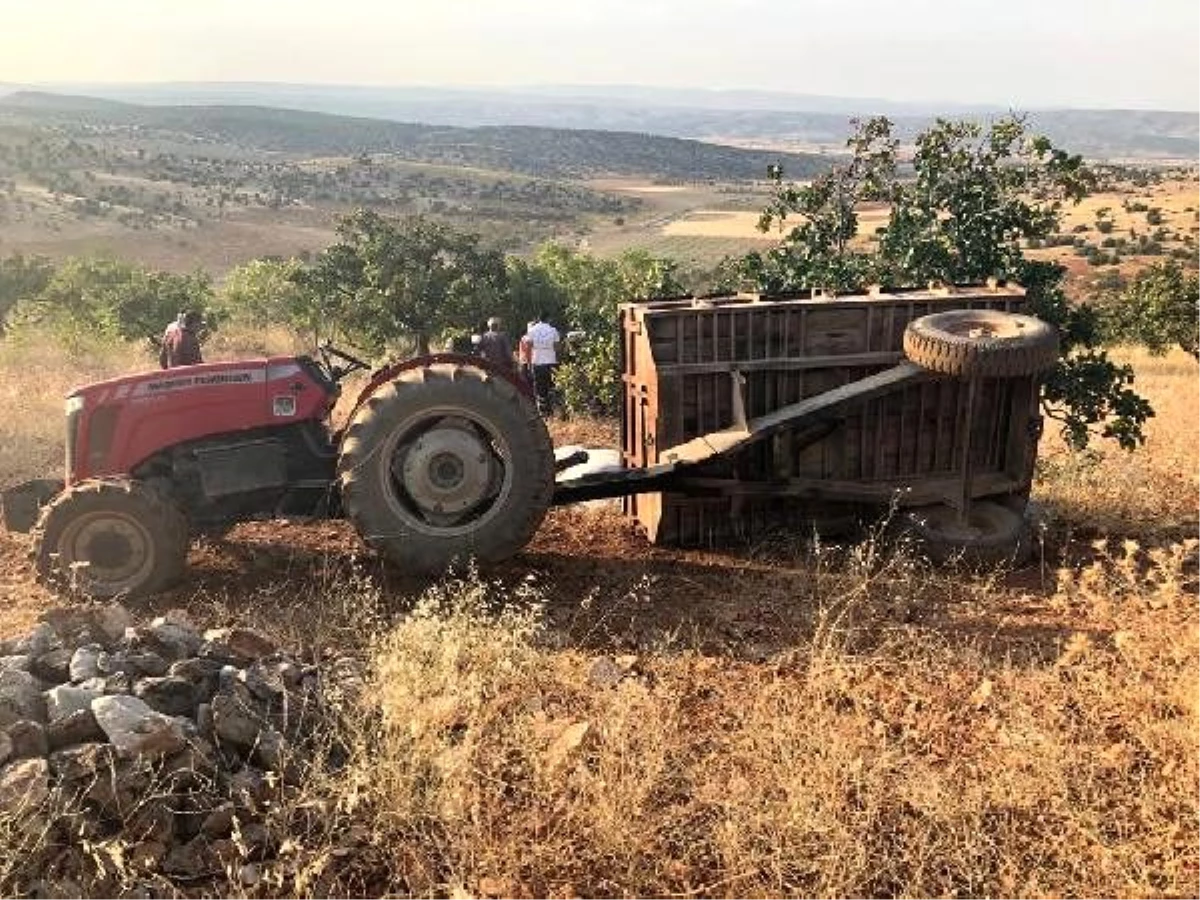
(0, 0, 1200, 109)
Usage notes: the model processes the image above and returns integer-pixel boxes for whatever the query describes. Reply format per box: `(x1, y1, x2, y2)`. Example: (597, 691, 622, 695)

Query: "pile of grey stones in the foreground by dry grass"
(0, 605, 356, 896)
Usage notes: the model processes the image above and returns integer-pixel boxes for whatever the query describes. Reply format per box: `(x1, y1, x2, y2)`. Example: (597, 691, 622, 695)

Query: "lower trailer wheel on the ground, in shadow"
(904, 500, 1032, 566)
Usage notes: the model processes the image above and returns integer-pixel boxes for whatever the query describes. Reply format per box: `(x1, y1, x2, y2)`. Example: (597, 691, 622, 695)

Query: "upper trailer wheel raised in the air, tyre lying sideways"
(904, 310, 1058, 378)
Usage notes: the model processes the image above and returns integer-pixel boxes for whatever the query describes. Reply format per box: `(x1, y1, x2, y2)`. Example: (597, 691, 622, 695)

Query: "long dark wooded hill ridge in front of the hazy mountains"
(0, 91, 828, 181)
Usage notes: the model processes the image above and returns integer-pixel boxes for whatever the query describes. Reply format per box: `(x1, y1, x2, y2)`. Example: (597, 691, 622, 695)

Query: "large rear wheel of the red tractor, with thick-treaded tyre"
(337, 364, 554, 574)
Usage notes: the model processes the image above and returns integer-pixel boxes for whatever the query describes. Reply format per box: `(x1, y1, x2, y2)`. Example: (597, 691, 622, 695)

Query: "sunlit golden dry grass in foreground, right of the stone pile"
(314, 547, 1200, 896)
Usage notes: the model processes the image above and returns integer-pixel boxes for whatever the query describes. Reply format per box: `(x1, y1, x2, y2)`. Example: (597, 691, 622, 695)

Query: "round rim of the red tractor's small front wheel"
(58, 511, 155, 594)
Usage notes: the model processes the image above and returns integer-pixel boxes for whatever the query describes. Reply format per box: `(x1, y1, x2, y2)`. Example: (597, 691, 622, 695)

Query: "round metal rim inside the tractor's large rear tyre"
(380, 407, 512, 536)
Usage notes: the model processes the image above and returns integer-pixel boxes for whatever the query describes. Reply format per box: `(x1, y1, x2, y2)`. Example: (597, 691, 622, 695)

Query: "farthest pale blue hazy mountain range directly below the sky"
(0, 83, 1200, 160)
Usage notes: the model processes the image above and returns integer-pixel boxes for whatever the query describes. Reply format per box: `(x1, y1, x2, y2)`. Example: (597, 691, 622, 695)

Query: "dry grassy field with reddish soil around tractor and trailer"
(0, 335, 1200, 896)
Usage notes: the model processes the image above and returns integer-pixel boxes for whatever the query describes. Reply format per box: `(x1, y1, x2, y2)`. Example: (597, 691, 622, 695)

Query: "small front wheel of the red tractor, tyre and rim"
(34, 479, 188, 600)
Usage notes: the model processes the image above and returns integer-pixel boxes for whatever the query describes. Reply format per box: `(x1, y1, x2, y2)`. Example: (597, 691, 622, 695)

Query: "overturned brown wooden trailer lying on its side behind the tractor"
(597, 283, 1057, 557)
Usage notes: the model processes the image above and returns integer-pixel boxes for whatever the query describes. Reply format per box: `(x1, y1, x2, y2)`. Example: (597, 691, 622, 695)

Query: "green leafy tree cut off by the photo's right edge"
(1100, 260, 1200, 360)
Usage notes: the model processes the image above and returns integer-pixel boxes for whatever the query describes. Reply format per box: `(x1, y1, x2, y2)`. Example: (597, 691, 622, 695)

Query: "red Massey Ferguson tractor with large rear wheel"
(4, 347, 554, 598)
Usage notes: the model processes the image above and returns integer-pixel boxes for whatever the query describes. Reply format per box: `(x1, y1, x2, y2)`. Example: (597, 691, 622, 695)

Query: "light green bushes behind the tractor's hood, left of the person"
(20, 258, 215, 350)
